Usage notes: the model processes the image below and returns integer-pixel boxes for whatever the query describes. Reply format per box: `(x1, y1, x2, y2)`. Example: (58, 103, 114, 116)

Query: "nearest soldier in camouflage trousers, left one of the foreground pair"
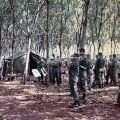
(69, 55, 80, 108)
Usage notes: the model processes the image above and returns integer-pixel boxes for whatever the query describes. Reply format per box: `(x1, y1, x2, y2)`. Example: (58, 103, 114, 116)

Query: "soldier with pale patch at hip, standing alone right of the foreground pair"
(95, 52, 105, 88)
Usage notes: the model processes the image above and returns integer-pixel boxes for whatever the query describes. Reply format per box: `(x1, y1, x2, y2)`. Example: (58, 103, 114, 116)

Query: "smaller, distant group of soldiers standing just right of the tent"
(37, 58, 62, 86)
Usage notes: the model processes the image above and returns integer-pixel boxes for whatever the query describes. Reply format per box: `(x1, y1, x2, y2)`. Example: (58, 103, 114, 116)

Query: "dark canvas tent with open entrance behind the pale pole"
(3, 52, 41, 75)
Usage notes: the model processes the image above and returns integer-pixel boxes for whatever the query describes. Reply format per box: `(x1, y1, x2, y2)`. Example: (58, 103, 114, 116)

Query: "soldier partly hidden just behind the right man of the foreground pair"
(87, 54, 93, 90)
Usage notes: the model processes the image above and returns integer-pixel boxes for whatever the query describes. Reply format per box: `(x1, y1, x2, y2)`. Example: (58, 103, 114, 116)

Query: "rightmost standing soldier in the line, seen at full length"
(110, 54, 118, 85)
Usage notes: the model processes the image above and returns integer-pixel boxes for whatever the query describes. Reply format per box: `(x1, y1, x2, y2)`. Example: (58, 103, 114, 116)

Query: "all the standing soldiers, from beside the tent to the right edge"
(33, 48, 119, 108)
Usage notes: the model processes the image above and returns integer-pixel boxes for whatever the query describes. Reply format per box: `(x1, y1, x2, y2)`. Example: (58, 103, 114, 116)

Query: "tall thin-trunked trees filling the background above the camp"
(0, 0, 120, 58)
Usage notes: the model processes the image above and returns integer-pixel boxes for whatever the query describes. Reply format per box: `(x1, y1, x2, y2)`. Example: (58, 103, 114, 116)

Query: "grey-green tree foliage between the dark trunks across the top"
(0, 0, 120, 56)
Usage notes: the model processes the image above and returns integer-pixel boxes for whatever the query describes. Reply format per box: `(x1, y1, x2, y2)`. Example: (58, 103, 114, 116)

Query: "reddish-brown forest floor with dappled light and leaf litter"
(0, 77, 120, 120)
